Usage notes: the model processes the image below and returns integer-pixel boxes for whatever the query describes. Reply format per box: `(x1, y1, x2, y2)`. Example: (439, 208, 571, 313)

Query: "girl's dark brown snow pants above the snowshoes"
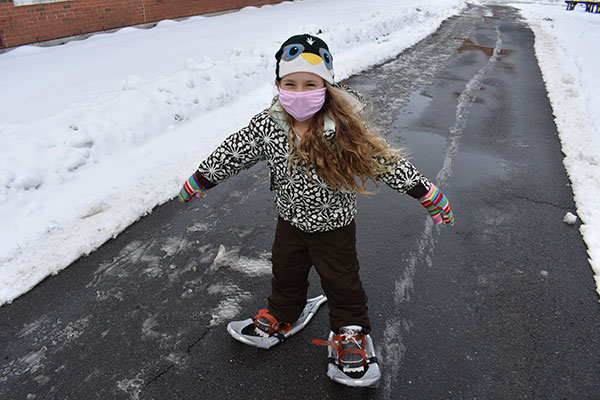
(268, 218, 371, 333)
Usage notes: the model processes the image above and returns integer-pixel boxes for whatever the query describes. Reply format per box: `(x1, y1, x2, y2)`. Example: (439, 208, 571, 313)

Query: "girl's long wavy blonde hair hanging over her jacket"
(288, 82, 401, 194)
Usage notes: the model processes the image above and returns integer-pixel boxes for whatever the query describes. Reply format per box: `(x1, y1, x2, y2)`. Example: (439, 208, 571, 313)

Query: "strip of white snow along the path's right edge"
(513, 2, 600, 294)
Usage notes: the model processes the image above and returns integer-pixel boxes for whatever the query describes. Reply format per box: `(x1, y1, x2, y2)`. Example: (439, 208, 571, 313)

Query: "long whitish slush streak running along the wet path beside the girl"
(381, 21, 502, 399)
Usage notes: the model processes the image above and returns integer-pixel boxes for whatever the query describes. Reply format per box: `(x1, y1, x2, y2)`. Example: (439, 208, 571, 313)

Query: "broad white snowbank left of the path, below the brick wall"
(0, 0, 464, 305)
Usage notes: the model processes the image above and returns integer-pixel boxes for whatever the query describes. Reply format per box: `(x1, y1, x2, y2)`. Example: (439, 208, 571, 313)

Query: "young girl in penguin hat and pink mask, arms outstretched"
(179, 35, 454, 382)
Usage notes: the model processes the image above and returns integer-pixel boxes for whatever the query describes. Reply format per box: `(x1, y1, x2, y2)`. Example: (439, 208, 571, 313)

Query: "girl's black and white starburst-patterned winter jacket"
(196, 87, 429, 233)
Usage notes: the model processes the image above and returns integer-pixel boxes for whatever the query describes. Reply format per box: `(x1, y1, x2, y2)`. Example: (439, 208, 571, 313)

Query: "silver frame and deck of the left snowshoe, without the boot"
(227, 295, 327, 349)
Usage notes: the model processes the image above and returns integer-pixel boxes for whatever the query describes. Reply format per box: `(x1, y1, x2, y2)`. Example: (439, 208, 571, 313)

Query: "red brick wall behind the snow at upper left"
(0, 0, 282, 48)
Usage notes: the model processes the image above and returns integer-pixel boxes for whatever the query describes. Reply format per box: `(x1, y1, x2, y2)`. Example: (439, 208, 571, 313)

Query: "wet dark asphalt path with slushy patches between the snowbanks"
(0, 3, 600, 399)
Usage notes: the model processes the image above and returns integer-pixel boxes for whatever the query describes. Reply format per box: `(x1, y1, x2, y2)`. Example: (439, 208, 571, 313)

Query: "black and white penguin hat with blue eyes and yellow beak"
(275, 34, 333, 84)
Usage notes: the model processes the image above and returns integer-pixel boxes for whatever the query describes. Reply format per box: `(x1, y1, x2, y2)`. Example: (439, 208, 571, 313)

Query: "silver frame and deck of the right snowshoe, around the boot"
(313, 332, 381, 387)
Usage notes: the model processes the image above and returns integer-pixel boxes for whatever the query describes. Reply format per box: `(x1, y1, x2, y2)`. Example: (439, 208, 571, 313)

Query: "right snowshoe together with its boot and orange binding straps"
(313, 325, 381, 387)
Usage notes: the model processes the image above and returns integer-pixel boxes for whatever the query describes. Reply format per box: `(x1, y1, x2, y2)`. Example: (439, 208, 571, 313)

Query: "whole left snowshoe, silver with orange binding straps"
(227, 295, 327, 349)
